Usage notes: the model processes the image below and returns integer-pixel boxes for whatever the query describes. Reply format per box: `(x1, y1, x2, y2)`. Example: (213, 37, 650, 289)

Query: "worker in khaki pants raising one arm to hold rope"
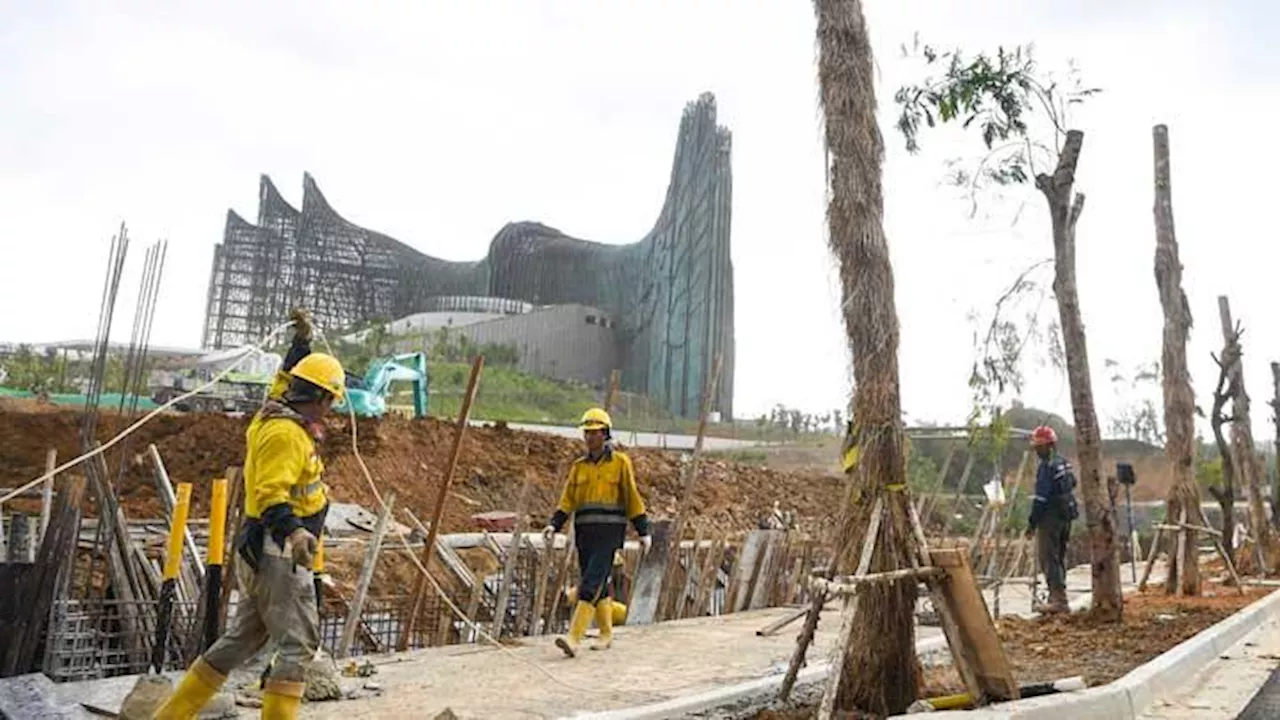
(155, 310, 344, 720)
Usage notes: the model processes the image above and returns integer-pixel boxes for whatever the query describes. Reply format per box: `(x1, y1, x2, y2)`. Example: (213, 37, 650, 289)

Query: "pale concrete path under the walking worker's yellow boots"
(42, 565, 1164, 720)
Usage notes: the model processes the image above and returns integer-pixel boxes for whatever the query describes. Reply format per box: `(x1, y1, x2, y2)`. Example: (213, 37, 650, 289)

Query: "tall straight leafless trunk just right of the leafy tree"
(1152, 126, 1201, 596)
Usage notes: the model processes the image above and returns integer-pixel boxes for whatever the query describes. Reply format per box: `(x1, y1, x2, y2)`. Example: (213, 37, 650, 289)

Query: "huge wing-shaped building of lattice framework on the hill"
(204, 94, 733, 418)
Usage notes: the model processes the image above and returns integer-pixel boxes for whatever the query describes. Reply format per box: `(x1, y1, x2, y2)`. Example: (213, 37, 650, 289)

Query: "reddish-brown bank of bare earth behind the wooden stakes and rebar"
(0, 404, 841, 533)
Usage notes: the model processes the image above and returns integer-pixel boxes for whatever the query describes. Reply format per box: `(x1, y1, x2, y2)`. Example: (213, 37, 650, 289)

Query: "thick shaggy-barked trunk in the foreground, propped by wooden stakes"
(814, 0, 920, 715)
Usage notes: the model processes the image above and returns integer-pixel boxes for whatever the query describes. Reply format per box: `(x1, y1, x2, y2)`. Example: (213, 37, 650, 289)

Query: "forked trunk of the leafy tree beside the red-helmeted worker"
(1036, 129, 1124, 619)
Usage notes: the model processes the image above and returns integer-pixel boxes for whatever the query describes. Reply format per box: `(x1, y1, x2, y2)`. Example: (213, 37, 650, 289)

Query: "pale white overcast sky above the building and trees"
(0, 0, 1280, 441)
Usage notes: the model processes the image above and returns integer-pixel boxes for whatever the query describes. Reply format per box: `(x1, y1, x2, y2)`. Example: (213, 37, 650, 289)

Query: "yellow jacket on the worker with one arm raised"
(244, 373, 329, 519)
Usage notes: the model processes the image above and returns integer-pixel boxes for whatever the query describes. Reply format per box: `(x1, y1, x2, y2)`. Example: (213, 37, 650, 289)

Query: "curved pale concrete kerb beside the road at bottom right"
(931, 592, 1280, 720)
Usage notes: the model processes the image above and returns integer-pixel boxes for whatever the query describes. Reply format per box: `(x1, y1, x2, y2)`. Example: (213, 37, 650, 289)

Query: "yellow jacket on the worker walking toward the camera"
(552, 450, 648, 534)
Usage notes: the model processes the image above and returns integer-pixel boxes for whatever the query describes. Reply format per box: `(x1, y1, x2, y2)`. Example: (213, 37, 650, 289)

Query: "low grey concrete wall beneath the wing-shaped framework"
(397, 305, 618, 386)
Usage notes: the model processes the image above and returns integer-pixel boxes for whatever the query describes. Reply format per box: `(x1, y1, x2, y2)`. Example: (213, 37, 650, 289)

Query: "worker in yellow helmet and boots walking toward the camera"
(543, 407, 653, 657)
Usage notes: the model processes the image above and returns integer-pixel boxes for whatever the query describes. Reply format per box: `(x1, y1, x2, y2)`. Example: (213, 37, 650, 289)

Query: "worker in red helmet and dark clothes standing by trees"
(1027, 425, 1080, 612)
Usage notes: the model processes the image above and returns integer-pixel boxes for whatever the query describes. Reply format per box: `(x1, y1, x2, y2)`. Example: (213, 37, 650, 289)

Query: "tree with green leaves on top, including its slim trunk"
(895, 46, 1123, 619)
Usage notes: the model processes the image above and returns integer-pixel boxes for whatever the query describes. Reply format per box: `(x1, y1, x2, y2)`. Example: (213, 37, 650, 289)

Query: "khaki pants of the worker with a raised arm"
(204, 534, 320, 683)
